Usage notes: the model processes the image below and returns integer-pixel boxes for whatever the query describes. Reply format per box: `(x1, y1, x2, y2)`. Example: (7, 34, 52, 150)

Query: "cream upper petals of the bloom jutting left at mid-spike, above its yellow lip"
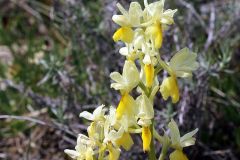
(110, 60, 140, 93)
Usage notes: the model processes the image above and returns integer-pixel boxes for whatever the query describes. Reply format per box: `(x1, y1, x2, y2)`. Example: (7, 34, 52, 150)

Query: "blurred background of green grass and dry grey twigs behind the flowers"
(0, 0, 240, 160)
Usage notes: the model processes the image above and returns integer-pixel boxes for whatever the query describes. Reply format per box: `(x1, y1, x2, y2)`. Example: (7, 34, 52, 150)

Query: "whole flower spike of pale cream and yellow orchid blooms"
(65, 0, 198, 160)
